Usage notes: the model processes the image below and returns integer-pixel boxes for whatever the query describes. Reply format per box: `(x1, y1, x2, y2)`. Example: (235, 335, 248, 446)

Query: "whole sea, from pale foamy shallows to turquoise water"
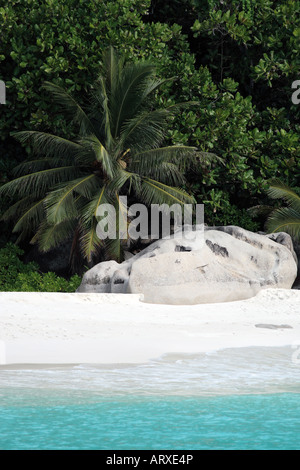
(0, 347, 300, 450)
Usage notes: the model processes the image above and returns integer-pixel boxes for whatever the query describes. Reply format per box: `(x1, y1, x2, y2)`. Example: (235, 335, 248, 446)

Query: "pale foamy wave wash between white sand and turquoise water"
(0, 347, 300, 396)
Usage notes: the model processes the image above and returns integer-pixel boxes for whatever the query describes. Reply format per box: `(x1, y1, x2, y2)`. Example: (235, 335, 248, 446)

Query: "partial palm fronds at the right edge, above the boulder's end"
(266, 180, 300, 240)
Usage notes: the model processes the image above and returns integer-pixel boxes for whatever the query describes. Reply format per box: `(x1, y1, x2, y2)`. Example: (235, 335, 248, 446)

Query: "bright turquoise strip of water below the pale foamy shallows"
(0, 394, 300, 450)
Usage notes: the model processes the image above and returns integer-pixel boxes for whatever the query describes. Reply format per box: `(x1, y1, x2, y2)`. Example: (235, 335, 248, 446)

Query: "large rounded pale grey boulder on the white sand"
(78, 226, 297, 304)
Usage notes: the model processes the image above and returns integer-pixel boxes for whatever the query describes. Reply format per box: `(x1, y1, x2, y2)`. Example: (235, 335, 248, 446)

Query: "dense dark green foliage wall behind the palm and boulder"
(0, 0, 300, 280)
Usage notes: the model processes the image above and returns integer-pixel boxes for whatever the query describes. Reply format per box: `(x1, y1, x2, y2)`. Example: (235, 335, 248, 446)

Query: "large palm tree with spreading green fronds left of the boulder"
(0, 47, 202, 268)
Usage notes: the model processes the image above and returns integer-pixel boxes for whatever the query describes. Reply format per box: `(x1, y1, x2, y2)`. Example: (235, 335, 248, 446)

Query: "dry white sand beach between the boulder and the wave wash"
(0, 289, 300, 366)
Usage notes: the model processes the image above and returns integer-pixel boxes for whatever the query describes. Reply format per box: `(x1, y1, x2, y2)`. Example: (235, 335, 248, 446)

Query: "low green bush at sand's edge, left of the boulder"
(0, 243, 81, 292)
